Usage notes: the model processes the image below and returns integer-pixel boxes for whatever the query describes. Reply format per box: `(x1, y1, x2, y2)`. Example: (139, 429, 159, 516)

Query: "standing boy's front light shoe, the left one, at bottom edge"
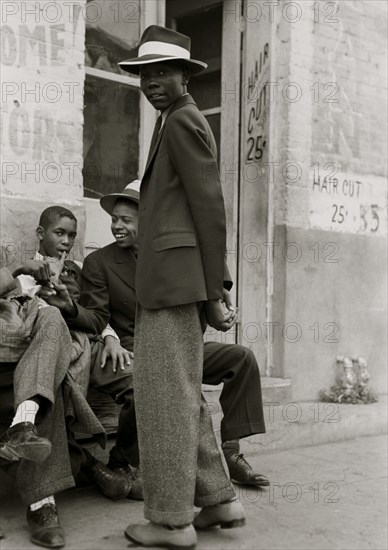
(124, 522, 197, 550)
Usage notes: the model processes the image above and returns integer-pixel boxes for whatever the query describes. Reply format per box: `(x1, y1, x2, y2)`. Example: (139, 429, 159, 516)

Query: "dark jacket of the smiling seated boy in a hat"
(69, 243, 136, 350)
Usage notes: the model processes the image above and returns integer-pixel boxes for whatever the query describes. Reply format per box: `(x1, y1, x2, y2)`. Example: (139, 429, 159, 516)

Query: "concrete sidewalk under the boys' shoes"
(0, 435, 388, 550)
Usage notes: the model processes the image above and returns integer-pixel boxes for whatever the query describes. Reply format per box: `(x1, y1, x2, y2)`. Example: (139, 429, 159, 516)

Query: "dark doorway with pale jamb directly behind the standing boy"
(166, 0, 241, 343)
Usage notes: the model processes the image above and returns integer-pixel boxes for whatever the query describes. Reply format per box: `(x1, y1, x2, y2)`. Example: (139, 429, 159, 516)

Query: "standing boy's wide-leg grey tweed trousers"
(134, 304, 235, 525)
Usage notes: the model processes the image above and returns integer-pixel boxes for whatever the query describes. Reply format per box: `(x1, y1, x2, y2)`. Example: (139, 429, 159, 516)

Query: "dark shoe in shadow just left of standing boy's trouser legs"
(81, 459, 132, 499)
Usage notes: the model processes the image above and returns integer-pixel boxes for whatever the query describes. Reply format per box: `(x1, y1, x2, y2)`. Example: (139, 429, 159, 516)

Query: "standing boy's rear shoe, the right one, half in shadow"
(193, 500, 245, 529)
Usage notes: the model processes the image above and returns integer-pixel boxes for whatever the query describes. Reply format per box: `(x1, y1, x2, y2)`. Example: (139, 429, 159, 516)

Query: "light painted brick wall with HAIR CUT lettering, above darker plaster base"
(275, 0, 387, 236)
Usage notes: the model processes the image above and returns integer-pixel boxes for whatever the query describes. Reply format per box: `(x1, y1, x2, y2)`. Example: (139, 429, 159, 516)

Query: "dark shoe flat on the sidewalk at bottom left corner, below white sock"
(27, 504, 66, 548)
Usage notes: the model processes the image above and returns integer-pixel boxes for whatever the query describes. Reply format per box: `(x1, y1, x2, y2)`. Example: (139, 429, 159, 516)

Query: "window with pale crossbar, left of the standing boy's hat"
(83, 0, 140, 199)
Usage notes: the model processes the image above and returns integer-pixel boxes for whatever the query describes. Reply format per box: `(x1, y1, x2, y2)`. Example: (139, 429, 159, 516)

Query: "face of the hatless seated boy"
(37, 216, 77, 258)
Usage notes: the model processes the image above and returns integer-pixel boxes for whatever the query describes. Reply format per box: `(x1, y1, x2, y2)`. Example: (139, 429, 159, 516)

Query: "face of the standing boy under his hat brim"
(139, 62, 190, 112)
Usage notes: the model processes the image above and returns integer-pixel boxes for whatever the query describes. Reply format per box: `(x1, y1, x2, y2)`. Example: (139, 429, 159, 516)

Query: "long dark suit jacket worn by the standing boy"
(136, 95, 226, 309)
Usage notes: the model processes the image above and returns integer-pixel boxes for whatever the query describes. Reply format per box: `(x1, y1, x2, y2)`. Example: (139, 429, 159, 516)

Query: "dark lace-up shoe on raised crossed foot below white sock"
(0, 422, 51, 462)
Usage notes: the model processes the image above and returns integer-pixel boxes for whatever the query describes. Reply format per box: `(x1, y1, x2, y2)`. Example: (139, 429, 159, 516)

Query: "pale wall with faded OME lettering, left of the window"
(1, 0, 85, 264)
